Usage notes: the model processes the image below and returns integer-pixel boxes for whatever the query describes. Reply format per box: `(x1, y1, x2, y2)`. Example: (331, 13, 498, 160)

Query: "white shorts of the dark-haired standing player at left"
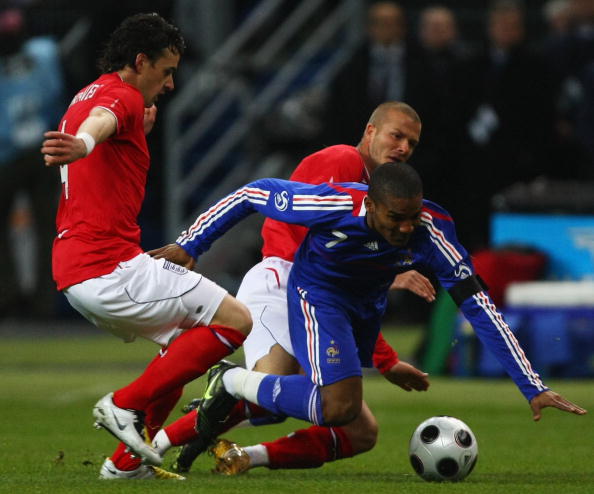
(64, 254, 227, 345)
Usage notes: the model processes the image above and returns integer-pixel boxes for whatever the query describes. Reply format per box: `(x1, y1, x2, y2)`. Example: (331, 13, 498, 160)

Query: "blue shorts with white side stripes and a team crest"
(287, 283, 381, 386)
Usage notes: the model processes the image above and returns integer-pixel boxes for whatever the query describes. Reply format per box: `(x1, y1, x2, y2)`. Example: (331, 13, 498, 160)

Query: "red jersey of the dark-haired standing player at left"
(52, 73, 150, 290)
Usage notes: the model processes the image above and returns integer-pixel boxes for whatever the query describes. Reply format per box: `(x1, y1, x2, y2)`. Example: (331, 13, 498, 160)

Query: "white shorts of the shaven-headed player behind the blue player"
(236, 257, 294, 369)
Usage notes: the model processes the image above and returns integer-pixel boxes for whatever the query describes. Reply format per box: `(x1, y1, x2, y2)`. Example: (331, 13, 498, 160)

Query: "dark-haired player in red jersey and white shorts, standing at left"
(41, 14, 251, 478)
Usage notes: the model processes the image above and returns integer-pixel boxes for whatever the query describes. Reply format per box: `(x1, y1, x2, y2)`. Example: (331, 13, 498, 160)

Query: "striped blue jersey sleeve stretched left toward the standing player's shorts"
(176, 178, 353, 258)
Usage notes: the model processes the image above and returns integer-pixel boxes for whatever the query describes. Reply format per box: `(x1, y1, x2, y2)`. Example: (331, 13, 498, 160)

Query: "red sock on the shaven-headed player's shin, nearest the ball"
(262, 425, 353, 468)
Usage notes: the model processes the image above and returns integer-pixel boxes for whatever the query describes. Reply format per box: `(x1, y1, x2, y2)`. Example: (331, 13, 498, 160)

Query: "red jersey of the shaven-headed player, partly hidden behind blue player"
(262, 144, 369, 262)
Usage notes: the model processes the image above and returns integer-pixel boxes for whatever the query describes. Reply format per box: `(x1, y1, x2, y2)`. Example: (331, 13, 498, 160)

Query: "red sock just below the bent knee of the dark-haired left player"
(113, 325, 245, 412)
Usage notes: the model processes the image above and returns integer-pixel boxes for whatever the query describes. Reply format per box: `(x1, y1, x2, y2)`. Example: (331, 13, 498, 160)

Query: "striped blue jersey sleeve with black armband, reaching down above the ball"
(421, 204, 548, 400)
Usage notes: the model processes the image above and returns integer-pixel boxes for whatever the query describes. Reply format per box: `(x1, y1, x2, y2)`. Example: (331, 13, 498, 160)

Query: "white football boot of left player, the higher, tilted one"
(93, 393, 163, 466)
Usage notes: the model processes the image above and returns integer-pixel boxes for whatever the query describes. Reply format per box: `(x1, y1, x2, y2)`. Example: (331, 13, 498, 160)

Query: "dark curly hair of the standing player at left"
(98, 12, 186, 74)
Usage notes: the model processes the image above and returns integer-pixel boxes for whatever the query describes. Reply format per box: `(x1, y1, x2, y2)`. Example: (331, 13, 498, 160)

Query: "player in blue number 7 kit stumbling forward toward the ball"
(148, 163, 586, 473)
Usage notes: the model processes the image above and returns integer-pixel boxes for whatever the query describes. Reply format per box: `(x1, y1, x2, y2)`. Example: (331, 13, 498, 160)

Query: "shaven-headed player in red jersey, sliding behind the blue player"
(150, 102, 435, 473)
